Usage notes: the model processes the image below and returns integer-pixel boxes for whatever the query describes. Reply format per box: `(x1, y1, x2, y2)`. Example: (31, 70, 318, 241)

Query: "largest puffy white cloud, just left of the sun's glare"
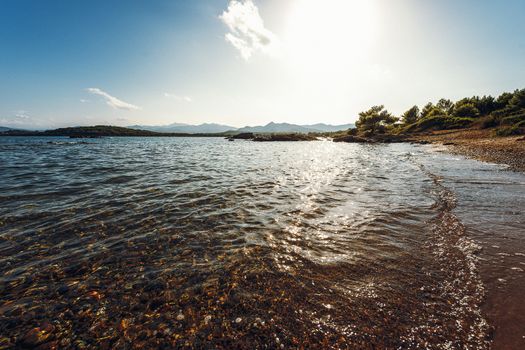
(219, 0, 279, 60)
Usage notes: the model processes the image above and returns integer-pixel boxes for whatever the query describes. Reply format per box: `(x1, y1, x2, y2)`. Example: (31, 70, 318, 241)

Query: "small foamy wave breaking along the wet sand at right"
(414, 165, 491, 349)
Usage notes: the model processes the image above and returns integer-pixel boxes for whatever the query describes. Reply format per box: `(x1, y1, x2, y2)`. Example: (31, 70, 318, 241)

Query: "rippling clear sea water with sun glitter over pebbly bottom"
(0, 137, 525, 349)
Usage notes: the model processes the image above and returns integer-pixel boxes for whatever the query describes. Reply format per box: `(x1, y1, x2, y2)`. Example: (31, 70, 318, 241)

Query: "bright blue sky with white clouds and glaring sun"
(0, 0, 525, 129)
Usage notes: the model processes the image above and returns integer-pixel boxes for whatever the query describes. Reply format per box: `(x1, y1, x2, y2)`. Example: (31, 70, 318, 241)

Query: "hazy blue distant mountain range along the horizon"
(129, 122, 355, 134)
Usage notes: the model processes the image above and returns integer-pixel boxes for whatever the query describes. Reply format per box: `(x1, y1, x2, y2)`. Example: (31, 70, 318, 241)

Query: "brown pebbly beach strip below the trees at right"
(414, 129, 525, 172)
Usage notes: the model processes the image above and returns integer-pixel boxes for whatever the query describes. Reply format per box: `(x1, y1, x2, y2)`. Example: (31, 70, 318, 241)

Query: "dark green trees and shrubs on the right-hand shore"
(328, 89, 525, 142)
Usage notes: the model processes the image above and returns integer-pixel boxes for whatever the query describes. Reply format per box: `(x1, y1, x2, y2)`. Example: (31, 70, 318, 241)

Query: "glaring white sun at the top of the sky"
(284, 0, 377, 72)
